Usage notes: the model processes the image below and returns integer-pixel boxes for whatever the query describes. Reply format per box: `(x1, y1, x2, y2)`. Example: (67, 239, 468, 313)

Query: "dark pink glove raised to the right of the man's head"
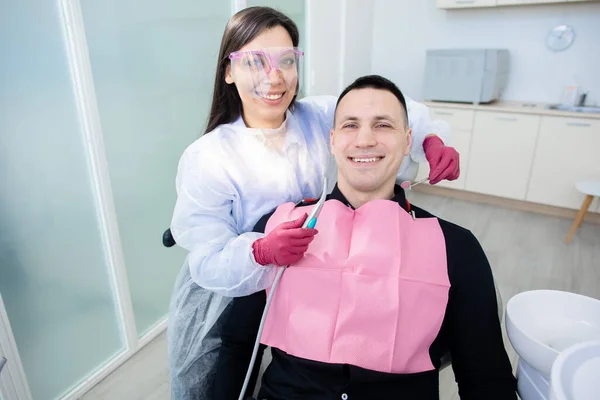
(423, 136, 460, 185)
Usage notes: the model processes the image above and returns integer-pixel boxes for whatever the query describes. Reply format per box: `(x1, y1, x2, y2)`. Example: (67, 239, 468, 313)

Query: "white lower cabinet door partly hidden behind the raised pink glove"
(417, 108, 475, 189)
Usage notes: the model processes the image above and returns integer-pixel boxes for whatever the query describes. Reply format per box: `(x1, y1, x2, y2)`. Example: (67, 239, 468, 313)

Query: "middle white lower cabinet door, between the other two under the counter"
(465, 111, 540, 200)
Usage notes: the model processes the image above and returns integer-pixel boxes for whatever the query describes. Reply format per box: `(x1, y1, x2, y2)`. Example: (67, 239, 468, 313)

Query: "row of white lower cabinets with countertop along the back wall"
(417, 102, 600, 213)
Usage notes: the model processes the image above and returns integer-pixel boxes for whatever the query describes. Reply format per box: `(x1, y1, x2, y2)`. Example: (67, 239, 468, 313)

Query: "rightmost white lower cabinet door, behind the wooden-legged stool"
(527, 116, 600, 209)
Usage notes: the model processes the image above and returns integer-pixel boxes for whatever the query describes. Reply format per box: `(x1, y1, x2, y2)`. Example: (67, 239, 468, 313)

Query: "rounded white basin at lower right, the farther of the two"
(506, 290, 600, 378)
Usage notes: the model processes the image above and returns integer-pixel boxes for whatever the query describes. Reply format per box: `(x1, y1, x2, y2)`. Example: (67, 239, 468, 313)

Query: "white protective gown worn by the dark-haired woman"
(168, 96, 450, 400)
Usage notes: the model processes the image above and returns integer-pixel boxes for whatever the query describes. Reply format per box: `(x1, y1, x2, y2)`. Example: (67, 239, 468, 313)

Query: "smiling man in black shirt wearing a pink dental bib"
(216, 76, 517, 400)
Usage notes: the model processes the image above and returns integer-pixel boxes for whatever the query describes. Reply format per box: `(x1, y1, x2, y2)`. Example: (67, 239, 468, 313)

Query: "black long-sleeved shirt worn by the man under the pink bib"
(217, 186, 517, 400)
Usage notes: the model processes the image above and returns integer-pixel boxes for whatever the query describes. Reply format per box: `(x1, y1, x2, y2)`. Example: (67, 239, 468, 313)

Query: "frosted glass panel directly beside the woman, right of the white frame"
(81, 0, 231, 335)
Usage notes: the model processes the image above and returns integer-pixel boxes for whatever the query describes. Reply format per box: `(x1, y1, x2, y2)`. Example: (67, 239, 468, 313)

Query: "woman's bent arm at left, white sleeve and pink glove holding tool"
(171, 148, 316, 297)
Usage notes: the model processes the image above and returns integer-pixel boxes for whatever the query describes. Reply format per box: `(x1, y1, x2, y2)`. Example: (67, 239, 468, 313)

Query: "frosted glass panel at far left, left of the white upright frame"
(0, 0, 125, 400)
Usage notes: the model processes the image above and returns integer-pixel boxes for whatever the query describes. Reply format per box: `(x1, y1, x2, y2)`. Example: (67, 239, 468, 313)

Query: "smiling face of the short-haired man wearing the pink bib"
(330, 88, 412, 197)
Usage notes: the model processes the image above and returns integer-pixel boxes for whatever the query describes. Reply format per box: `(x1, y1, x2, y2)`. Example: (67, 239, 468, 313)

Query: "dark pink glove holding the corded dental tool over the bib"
(252, 214, 318, 266)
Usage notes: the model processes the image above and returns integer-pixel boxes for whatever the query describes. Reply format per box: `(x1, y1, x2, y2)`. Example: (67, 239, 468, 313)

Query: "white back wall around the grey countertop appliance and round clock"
(371, 0, 600, 103)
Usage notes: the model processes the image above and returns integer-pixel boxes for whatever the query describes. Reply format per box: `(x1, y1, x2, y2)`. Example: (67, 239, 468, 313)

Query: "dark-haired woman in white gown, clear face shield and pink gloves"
(168, 7, 459, 400)
